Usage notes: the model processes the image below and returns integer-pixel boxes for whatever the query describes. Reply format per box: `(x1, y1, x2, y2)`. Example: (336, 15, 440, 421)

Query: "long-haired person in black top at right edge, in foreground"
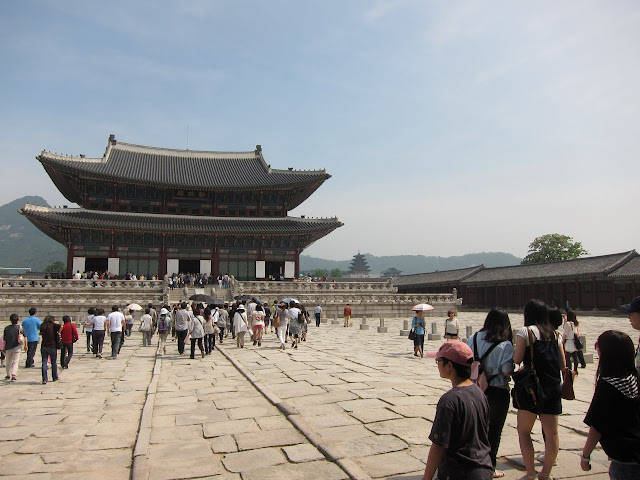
(580, 330, 640, 480)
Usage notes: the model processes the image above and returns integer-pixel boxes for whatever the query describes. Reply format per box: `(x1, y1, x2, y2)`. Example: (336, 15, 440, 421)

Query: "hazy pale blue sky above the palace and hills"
(0, 0, 640, 259)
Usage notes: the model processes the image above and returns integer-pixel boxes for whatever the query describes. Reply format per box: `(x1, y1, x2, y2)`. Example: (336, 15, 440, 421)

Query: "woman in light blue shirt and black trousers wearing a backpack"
(467, 308, 513, 478)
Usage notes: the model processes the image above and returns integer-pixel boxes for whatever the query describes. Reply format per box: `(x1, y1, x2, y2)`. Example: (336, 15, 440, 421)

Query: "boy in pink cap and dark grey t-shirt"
(423, 341, 493, 480)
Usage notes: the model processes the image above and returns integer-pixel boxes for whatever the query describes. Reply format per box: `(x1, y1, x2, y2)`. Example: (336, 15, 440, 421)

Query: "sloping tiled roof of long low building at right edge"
(461, 250, 638, 284)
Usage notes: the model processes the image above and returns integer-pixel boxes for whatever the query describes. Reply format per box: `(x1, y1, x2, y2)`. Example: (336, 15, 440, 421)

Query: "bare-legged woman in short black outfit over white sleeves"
(513, 299, 565, 480)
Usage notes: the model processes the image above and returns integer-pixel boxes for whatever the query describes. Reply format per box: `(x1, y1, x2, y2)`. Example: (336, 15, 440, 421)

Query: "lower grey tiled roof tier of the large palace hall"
(19, 204, 343, 236)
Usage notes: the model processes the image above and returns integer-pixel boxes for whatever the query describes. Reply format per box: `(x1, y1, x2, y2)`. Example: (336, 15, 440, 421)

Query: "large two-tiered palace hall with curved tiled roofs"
(20, 135, 342, 280)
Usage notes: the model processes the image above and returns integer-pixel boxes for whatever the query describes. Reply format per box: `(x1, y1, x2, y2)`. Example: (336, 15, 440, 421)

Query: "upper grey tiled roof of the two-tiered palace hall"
(37, 138, 331, 190)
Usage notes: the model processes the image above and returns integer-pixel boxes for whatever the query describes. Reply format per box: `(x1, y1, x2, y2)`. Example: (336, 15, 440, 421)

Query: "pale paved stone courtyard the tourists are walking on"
(0, 312, 638, 480)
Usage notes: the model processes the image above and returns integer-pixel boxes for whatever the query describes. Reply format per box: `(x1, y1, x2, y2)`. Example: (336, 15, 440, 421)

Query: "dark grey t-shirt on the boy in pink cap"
(429, 384, 493, 480)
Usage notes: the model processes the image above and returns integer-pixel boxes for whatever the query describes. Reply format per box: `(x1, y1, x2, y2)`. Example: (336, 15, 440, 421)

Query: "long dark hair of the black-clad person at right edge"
(596, 330, 638, 380)
